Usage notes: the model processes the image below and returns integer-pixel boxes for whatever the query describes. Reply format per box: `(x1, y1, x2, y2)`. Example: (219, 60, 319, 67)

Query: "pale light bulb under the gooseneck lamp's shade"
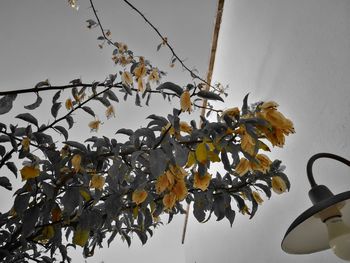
(325, 217, 350, 261)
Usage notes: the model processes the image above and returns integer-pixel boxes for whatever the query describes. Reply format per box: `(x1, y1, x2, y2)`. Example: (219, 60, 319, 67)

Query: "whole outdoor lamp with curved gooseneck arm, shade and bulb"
(281, 153, 350, 261)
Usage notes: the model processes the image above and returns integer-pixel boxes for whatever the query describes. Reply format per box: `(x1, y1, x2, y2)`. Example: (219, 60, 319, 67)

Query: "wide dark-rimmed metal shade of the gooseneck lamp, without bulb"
(281, 191, 350, 254)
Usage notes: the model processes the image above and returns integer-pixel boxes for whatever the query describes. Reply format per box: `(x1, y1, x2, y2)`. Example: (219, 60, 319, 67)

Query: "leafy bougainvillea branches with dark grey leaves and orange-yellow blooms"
(0, 1, 294, 262)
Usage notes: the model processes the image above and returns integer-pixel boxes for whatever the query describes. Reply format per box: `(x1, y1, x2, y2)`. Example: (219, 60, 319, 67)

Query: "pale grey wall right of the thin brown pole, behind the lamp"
(186, 0, 350, 263)
